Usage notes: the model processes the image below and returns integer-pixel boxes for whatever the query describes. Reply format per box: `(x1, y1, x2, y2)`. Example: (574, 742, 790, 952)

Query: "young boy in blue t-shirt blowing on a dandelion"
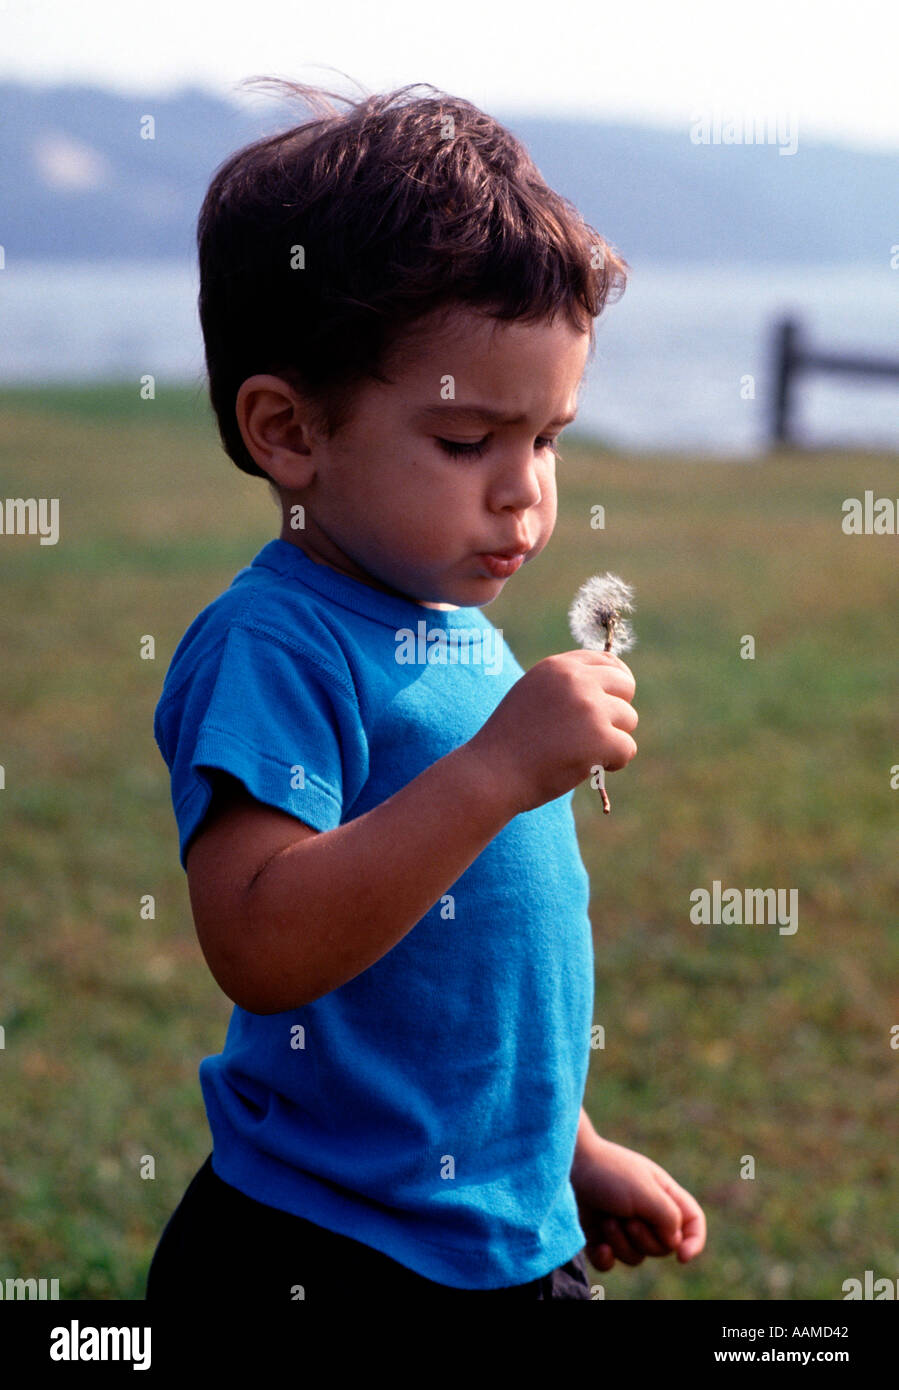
(147, 83, 704, 1304)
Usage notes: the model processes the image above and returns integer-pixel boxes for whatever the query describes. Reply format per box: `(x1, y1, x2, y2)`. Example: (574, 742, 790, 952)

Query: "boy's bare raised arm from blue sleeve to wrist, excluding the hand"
(186, 744, 516, 1013)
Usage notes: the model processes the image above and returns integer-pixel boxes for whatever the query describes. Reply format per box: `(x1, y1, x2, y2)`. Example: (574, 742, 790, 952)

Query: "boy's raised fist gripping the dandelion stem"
(468, 651, 636, 812)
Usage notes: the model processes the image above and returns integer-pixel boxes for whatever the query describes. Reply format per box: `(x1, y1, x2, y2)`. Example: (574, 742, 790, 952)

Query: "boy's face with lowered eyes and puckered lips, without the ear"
(242, 310, 589, 607)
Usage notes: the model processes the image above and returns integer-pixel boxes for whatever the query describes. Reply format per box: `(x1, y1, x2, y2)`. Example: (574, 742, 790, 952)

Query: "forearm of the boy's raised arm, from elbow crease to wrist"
(242, 744, 516, 1013)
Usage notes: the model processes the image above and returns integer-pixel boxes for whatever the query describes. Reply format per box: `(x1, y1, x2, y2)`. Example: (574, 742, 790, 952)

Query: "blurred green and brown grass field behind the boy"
(0, 386, 899, 1300)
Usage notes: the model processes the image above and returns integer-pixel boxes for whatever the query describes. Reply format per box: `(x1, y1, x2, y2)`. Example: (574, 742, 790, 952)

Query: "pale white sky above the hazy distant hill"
(0, 0, 899, 150)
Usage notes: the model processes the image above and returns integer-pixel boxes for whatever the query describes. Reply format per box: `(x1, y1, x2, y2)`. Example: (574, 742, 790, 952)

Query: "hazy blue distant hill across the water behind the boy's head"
(0, 82, 899, 265)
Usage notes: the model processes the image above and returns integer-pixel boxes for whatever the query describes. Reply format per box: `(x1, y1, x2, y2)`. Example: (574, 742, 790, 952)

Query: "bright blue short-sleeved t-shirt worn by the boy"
(154, 539, 593, 1289)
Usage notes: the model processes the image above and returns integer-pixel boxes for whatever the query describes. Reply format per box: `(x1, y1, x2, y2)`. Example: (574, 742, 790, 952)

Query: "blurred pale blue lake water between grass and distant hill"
(0, 253, 899, 457)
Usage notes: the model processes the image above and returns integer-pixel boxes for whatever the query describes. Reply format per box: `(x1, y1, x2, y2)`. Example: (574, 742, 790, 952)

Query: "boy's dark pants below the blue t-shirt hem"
(146, 1154, 591, 1305)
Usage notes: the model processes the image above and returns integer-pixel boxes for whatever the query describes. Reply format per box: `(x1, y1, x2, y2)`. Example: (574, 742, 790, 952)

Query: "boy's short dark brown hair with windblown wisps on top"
(197, 78, 627, 477)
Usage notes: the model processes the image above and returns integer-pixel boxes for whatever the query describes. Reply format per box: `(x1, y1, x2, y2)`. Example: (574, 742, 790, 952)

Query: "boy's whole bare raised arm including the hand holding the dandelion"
(186, 651, 636, 1013)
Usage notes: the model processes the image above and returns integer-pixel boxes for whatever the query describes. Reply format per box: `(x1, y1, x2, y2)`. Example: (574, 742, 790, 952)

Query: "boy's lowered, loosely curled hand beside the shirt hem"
(571, 1136, 706, 1272)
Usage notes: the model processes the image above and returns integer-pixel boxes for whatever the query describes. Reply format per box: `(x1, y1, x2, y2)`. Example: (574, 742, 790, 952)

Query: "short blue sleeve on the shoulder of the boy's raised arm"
(154, 626, 368, 869)
